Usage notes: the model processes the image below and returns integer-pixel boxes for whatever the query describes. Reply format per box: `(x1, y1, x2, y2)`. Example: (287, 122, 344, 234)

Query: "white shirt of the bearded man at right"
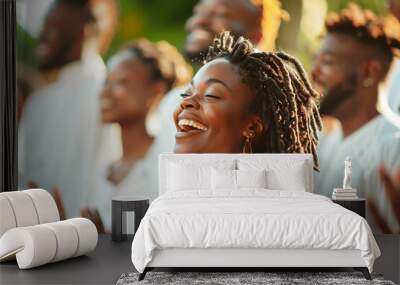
(315, 115, 400, 231)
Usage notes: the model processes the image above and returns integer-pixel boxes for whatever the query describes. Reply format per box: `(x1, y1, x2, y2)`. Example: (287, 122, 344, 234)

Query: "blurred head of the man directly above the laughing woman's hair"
(184, 0, 285, 64)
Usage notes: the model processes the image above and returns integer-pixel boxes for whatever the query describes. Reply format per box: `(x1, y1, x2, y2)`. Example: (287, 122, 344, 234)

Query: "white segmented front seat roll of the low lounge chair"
(0, 218, 98, 269)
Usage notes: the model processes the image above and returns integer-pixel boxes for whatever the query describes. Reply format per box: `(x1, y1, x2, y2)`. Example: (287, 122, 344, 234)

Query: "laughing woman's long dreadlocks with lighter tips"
(206, 32, 322, 169)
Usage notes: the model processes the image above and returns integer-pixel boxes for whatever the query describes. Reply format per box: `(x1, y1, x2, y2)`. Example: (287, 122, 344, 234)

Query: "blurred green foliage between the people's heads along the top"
(17, 0, 387, 67)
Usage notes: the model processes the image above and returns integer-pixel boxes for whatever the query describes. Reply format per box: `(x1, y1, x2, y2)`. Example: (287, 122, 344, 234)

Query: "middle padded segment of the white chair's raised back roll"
(0, 191, 39, 227)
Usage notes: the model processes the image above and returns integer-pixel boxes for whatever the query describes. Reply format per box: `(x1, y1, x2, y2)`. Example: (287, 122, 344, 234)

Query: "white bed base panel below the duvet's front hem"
(147, 248, 367, 267)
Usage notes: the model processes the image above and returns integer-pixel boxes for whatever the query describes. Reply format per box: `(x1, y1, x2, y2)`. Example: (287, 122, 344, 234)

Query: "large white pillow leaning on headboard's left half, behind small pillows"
(167, 162, 211, 191)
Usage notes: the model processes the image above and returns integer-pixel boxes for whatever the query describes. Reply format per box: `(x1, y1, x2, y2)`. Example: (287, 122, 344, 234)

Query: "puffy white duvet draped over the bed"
(132, 189, 380, 272)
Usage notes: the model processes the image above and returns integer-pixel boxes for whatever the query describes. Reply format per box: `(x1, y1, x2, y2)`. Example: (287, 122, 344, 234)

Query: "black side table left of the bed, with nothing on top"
(111, 196, 150, 241)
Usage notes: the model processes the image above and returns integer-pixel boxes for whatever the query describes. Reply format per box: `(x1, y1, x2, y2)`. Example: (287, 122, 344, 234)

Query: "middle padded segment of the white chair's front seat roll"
(43, 221, 79, 262)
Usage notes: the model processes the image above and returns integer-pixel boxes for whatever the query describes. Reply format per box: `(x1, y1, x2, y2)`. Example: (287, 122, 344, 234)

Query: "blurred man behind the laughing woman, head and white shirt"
(151, 0, 287, 160)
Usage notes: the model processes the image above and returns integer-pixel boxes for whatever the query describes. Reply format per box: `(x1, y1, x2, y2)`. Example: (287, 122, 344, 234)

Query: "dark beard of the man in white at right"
(319, 72, 358, 116)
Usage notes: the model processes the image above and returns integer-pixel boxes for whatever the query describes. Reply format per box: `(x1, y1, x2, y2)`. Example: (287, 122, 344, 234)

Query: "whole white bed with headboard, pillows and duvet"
(132, 154, 380, 278)
